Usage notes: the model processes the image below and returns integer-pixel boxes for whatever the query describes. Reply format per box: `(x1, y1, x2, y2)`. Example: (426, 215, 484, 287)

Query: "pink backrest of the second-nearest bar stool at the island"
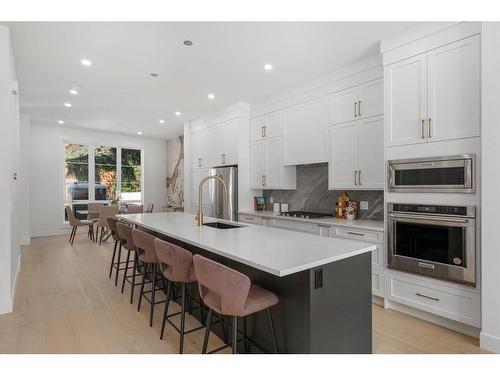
(155, 238, 194, 282)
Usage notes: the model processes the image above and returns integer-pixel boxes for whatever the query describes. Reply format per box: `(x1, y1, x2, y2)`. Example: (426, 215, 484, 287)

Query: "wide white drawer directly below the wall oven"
(386, 271, 481, 327)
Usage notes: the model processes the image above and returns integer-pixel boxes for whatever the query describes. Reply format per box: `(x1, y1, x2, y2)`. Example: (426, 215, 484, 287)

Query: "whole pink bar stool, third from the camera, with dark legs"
(132, 228, 166, 327)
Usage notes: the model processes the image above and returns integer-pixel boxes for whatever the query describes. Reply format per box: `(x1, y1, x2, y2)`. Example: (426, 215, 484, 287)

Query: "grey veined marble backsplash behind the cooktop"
(263, 163, 384, 220)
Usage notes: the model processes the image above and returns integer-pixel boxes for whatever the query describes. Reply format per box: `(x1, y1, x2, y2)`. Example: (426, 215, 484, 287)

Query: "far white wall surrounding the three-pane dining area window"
(30, 124, 167, 237)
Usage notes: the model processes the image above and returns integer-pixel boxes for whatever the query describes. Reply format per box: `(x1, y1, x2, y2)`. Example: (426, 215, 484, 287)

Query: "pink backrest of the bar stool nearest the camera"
(193, 254, 252, 316)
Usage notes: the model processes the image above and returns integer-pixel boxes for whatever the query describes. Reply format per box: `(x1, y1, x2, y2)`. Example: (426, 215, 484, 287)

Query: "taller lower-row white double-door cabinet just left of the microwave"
(328, 116, 385, 190)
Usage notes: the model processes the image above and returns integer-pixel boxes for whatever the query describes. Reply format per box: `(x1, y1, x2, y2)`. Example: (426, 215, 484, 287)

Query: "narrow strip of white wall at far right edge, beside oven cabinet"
(480, 22, 500, 353)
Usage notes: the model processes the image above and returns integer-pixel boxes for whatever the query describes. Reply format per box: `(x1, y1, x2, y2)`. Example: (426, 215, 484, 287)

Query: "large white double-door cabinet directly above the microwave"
(384, 35, 481, 146)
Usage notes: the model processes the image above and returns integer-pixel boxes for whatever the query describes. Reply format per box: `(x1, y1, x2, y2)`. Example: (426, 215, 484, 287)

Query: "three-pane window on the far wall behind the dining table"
(64, 143, 143, 221)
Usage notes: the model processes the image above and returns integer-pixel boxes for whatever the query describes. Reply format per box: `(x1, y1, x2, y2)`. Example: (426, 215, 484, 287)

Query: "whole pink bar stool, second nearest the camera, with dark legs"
(154, 238, 204, 354)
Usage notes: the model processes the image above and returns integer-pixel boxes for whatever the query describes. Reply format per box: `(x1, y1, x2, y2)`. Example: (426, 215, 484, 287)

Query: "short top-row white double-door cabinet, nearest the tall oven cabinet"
(330, 79, 384, 124)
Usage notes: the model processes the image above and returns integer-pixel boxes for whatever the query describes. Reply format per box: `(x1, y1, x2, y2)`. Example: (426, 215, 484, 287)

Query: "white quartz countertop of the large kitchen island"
(118, 212, 376, 277)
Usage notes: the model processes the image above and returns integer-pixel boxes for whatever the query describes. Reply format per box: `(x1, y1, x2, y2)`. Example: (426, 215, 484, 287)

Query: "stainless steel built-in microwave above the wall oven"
(387, 154, 476, 193)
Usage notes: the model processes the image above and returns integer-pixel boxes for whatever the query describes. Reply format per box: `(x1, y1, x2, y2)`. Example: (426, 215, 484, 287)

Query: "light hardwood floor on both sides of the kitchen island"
(0, 233, 485, 353)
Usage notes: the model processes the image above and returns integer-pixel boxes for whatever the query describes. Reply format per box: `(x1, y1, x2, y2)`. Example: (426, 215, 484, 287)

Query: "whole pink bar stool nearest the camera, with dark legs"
(193, 254, 279, 354)
